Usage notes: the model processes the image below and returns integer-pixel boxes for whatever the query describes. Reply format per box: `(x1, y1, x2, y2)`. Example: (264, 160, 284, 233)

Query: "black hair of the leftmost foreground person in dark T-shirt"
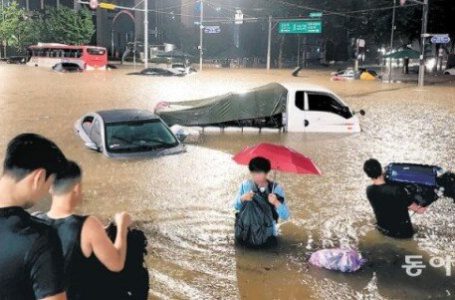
(3, 133, 66, 181)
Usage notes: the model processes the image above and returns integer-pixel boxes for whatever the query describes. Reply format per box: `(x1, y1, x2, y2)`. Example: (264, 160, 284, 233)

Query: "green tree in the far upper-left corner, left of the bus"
(0, 1, 39, 56)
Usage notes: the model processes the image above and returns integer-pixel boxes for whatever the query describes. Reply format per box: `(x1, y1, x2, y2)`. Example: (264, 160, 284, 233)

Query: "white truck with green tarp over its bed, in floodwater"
(155, 83, 364, 133)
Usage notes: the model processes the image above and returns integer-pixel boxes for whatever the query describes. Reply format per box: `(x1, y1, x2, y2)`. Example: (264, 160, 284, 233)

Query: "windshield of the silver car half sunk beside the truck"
(106, 119, 178, 152)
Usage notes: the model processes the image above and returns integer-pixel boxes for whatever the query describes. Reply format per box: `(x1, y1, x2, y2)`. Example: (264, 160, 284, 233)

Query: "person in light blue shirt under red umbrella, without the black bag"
(234, 156, 289, 236)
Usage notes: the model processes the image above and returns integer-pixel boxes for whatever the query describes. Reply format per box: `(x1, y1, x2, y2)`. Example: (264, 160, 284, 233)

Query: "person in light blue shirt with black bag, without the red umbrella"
(234, 157, 289, 247)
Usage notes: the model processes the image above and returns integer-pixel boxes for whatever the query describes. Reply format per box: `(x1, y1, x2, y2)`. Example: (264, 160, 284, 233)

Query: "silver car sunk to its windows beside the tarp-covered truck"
(74, 109, 185, 158)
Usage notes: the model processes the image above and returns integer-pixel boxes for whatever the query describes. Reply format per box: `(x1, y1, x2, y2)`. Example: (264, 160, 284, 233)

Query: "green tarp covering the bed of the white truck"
(156, 83, 287, 126)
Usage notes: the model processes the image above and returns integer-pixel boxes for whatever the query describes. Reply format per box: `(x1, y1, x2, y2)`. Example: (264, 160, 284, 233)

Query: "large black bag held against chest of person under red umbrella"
(235, 184, 276, 247)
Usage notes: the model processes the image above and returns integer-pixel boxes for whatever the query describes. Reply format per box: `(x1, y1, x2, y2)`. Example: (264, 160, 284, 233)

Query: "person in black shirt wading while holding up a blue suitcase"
(363, 159, 425, 238)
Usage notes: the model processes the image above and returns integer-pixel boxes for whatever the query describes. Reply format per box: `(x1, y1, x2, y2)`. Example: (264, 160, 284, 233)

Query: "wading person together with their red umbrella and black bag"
(232, 143, 321, 247)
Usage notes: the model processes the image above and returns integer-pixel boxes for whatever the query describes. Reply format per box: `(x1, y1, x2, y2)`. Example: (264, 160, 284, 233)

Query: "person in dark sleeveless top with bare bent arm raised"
(35, 161, 131, 300)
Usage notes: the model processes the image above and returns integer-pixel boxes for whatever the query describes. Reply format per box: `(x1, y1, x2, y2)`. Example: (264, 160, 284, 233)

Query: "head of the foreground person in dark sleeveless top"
(51, 161, 82, 206)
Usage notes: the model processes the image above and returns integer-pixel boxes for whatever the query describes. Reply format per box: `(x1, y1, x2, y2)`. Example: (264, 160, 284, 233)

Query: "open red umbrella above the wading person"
(232, 143, 321, 175)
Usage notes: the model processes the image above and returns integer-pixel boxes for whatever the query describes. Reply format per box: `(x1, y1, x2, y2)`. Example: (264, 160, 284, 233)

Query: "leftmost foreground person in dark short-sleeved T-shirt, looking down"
(0, 133, 66, 300)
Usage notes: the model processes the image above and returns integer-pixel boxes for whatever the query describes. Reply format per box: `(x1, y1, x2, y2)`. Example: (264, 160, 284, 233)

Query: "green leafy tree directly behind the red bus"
(39, 6, 95, 45)
